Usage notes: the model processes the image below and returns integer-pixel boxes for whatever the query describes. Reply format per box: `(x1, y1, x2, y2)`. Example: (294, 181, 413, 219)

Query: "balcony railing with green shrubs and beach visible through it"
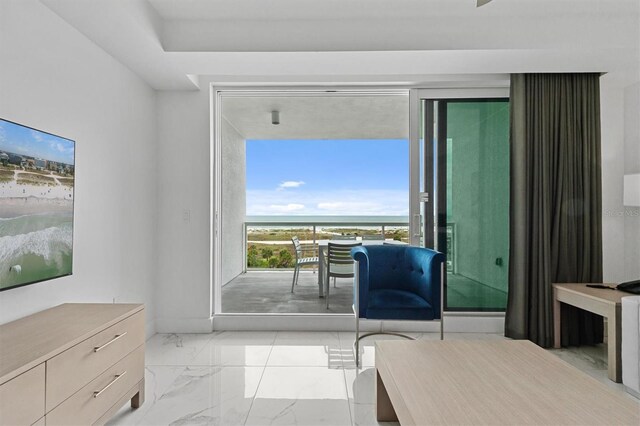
(244, 216, 409, 270)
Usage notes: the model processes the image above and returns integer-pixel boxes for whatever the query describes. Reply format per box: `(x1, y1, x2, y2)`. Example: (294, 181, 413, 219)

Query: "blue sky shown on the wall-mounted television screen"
(0, 119, 74, 165)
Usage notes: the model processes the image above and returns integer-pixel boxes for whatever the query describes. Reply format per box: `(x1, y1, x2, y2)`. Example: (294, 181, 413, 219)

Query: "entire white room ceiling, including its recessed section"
(41, 0, 640, 90)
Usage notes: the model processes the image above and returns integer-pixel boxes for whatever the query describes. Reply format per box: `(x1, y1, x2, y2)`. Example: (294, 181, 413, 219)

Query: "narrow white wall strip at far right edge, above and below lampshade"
(623, 83, 640, 281)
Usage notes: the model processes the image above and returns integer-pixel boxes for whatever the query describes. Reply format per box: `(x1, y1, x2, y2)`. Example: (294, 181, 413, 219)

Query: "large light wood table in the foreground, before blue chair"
(376, 340, 640, 426)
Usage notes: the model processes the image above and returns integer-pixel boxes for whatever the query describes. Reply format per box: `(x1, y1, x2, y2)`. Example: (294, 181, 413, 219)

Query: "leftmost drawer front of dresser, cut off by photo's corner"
(0, 363, 44, 425)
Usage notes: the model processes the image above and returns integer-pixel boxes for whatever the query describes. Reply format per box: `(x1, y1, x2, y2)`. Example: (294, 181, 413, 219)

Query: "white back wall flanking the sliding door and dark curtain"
(152, 76, 625, 332)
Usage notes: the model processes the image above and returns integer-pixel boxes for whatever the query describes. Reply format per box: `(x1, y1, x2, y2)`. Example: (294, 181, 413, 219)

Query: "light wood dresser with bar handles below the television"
(0, 303, 145, 425)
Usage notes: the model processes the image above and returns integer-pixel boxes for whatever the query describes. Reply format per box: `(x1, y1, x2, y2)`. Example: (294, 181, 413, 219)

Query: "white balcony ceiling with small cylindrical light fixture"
(222, 95, 409, 139)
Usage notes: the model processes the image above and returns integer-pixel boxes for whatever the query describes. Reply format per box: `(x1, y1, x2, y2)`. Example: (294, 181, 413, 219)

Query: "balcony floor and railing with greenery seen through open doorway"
(222, 216, 409, 314)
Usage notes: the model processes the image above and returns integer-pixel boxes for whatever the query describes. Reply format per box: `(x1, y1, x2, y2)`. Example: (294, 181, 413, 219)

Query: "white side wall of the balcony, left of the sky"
(220, 118, 247, 285)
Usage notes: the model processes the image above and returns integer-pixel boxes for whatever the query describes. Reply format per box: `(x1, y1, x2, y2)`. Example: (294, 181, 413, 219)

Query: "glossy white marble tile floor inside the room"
(108, 332, 633, 425)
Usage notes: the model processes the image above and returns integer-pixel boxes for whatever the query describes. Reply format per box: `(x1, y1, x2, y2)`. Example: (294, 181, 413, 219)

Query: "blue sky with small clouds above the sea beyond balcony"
(246, 139, 409, 215)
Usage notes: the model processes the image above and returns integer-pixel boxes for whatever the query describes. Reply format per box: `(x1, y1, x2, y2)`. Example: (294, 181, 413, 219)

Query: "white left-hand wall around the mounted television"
(0, 0, 157, 334)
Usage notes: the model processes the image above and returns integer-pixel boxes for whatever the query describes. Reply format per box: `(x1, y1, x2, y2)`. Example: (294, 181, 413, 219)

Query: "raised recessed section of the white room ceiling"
(154, 0, 637, 52)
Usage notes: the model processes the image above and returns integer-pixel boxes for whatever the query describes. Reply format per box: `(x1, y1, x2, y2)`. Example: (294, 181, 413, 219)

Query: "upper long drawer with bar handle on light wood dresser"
(46, 311, 144, 412)
